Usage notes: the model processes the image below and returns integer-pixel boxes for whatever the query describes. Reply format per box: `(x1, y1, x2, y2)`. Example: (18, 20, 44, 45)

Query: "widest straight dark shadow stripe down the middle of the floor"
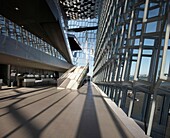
(76, 82, 101, 138)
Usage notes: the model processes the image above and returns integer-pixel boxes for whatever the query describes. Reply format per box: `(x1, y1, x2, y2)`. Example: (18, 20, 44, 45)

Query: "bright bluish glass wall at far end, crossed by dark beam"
(68, 18, 98, 76)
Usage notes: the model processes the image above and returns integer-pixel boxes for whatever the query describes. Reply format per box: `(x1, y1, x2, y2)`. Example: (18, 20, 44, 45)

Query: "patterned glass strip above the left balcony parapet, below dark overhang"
(0, 15, 66, 61)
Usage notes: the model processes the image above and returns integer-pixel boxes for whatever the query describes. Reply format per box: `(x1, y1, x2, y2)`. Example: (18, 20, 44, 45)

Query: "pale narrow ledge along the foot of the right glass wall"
(92, 83, 149, 138)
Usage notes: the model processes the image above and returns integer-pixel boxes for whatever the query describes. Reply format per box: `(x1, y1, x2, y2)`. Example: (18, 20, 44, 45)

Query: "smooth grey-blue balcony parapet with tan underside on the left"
(0, 34, 73, 72)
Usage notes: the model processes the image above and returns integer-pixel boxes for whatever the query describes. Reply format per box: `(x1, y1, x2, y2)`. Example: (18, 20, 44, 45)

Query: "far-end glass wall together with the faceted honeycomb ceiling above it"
(60, 0, 101, 76)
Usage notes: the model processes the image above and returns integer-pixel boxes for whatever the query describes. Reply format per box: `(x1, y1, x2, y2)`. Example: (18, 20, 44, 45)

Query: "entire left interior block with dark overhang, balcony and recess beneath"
(0, 0, 73, 87)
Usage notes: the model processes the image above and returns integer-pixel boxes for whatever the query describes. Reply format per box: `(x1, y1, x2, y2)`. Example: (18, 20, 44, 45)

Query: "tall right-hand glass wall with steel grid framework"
(93, 0, 170, 137)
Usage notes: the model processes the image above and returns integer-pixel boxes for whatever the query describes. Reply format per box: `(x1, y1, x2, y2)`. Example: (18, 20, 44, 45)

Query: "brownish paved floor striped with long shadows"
(0, 83, 133, 138)
